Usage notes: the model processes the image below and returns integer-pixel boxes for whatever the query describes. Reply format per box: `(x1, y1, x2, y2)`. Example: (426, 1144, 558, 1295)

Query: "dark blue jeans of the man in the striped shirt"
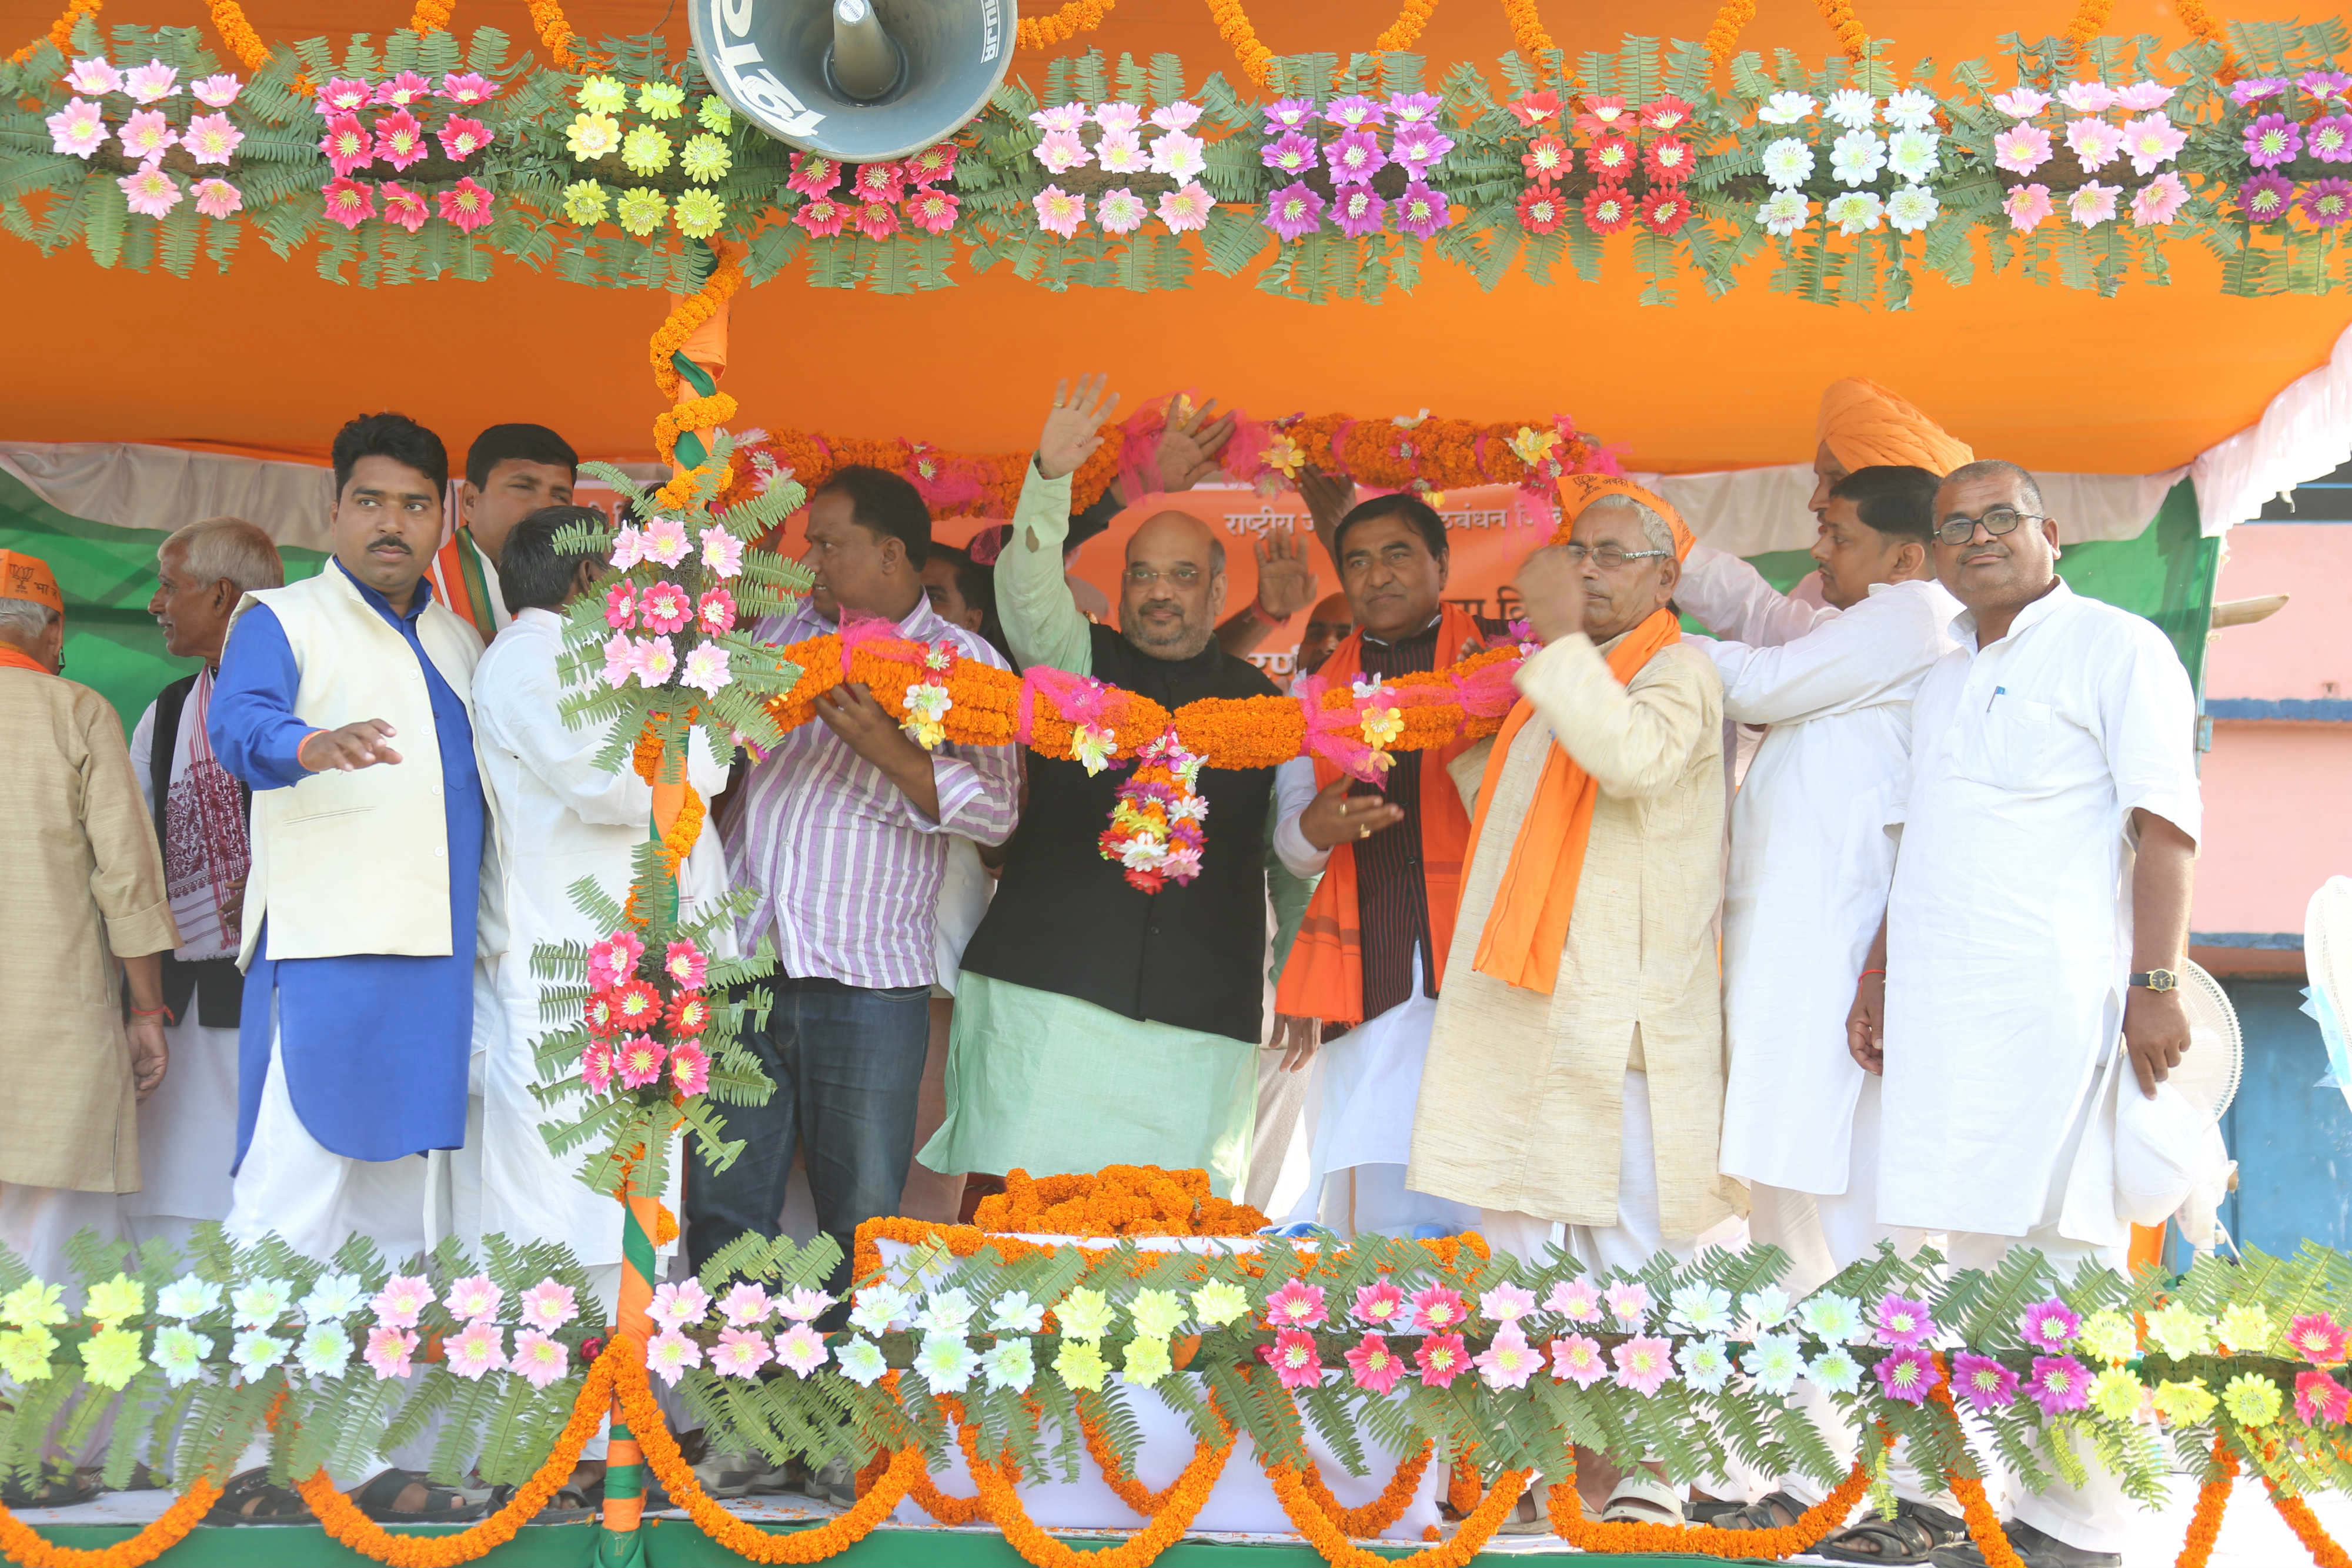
(687, 980, 931, 1326)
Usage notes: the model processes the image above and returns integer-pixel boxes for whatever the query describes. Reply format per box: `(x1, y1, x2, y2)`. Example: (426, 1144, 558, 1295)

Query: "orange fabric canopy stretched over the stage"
(0, 0, 2352, 473)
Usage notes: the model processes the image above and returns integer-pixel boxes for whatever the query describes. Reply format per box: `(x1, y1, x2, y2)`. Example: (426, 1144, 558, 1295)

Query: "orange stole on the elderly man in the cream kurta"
(1463, 609, 1682, 994)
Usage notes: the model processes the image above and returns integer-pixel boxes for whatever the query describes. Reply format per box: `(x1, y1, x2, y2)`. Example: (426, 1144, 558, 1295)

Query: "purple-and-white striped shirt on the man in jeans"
(727, 600, 1021, 987)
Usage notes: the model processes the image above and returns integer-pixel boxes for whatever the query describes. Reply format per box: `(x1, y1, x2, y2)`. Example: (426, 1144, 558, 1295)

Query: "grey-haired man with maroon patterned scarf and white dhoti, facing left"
(122, 517, 287, 1248)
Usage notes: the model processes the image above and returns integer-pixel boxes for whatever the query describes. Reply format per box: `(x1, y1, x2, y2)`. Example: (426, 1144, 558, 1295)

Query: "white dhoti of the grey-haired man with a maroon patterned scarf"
(122, 1020, 238, 1253)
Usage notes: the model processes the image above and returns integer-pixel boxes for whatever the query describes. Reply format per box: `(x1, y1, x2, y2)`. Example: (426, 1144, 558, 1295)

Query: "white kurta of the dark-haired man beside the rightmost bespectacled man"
(1708, 581, 1959, 1194)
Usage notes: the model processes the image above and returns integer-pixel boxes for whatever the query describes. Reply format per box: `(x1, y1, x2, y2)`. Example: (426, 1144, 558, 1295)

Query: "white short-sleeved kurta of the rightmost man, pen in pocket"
(1879, 583, 2201, 1246)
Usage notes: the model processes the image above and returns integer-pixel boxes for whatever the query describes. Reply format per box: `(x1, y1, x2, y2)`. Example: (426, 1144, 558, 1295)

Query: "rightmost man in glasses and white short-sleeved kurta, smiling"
(1849, 461, 2201, 1568)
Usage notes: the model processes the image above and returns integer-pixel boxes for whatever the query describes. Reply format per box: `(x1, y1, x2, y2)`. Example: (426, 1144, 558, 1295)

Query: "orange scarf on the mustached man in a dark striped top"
(1275, 604, 1482, 1025)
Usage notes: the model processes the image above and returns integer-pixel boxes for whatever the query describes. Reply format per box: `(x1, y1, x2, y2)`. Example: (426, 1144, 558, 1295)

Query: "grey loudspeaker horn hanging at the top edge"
(687, 0, 1014, 162)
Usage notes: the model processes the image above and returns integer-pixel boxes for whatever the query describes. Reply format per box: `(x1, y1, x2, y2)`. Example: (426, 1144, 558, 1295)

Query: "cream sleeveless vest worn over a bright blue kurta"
(230, 562, 487, 966)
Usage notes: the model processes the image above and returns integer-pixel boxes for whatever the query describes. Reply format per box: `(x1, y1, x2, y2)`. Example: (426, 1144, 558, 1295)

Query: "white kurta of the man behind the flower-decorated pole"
(473, 609, 734, 1267)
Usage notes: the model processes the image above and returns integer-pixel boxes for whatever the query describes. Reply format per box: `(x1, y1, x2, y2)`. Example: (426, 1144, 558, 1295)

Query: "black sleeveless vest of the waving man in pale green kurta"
(964, 626, 1275, 1044)
